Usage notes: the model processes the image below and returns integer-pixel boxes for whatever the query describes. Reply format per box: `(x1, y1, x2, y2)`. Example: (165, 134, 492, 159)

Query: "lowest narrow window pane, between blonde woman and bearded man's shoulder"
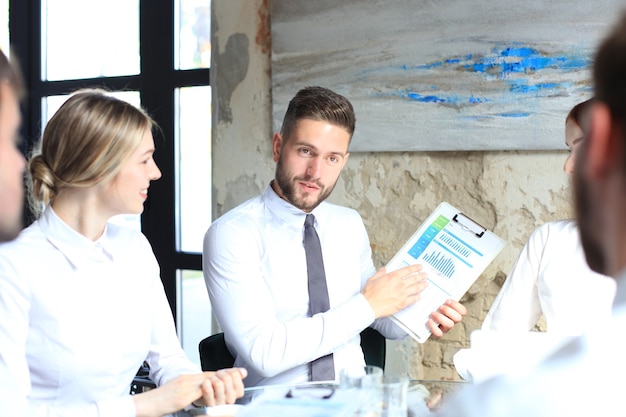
(176, 270, 217, 365)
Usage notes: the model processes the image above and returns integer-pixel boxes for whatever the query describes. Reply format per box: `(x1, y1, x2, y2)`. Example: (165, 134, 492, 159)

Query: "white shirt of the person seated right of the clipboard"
(453, 219, 615, 380)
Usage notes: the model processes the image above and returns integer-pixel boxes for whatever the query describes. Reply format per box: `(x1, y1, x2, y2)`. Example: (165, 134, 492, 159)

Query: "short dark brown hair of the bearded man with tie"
(280, 87, 356, 139)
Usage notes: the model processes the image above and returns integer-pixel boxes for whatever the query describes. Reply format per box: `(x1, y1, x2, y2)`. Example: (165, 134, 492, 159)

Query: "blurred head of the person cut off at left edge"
(0, 51, 26, 242)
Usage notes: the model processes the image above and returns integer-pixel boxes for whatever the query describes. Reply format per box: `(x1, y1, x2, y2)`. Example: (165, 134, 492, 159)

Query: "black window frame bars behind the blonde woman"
(9, 0, 205, 319)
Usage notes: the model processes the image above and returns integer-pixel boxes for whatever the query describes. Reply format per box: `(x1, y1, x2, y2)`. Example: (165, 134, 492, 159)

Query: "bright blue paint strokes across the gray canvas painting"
(364, 42, 591, 118)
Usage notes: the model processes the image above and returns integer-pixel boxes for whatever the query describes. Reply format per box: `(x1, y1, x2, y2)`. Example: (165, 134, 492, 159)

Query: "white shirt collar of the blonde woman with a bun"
(38, 206, 114, 268)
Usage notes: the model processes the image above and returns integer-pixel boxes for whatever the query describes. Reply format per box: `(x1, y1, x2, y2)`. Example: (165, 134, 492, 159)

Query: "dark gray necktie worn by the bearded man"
(302, 214, 335, 381)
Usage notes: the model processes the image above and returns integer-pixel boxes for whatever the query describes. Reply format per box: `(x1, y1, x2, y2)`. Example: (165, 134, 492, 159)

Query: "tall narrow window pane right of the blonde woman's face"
(176, 86, 212, 252)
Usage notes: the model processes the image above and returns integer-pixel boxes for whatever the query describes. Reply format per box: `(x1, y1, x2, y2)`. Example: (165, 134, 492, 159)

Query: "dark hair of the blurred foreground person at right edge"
(593, 13, 626, 126)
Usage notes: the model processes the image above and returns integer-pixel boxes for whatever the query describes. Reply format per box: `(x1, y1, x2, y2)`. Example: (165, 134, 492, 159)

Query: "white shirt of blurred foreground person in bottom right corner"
(438, 273, 626, 417)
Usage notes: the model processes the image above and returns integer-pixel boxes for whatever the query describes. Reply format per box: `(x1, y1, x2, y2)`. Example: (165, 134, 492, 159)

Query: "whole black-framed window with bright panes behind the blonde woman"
(10, 0, 213, 363)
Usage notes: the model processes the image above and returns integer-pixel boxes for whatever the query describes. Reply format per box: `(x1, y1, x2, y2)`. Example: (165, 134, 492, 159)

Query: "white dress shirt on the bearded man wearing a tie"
(203, 186, 406, 386)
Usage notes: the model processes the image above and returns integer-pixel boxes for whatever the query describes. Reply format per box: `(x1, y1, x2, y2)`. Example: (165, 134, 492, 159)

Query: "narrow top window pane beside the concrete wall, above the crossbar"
(174, 0, 211, 70)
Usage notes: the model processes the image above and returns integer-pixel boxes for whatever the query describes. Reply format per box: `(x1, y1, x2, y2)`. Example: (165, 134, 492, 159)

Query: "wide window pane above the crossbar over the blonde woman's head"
(41, 0, 140, 80)
